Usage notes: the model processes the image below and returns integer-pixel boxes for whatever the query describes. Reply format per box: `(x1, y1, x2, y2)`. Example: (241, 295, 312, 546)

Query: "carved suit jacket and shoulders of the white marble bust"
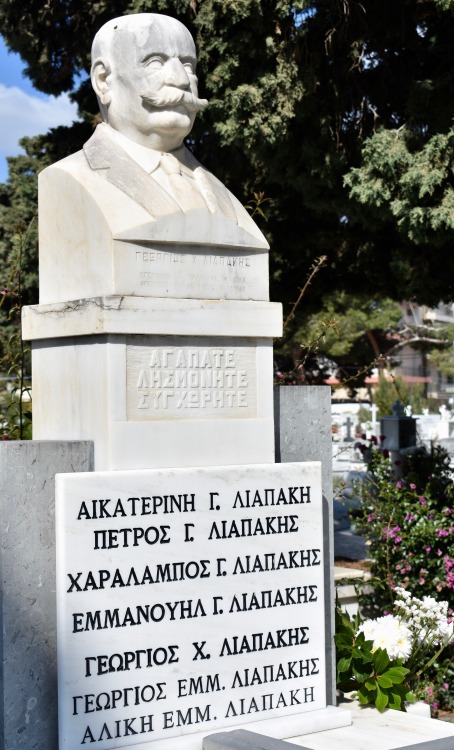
(38, 124, 269, 303)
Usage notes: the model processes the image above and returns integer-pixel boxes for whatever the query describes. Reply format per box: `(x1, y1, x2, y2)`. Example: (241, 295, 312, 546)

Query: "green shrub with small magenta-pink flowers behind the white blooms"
(355, 448, 454, 707)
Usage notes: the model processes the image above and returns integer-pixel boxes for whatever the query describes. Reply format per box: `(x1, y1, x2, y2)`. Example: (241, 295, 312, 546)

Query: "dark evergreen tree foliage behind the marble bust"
(0, 0, 454, 338)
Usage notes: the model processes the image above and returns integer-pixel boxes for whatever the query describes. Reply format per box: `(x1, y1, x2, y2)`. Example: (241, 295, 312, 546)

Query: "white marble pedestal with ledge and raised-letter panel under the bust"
(23, 297, 282, 470)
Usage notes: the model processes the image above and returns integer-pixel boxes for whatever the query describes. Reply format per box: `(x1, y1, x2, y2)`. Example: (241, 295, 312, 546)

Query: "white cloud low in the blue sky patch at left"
(0, 83, 77, 182)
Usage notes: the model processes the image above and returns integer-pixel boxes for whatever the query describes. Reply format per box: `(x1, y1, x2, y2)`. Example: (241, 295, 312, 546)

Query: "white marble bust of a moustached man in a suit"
(39, 13, 268, 302)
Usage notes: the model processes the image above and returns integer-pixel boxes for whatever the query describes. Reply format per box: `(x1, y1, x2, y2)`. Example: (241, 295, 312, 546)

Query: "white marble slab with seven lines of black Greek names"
(56, 462, 335, 750)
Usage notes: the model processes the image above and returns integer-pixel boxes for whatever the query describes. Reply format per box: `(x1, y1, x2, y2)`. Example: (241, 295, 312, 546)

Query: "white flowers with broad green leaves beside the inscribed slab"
(335, 588, 453, 711)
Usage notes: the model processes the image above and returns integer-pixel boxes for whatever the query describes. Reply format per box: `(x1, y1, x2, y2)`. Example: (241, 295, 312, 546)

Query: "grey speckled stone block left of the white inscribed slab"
(0, 440, 93, 750)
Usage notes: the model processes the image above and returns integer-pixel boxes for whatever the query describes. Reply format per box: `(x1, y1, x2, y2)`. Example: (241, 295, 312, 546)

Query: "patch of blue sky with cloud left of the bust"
(0, 36, 77, 182)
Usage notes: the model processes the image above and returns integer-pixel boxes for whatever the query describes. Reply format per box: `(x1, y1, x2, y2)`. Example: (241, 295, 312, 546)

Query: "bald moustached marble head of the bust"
(91, 13, 207, 151)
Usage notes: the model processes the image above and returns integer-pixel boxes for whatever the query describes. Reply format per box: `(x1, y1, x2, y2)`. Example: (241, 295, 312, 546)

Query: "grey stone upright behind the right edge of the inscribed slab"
(274, 385, 336, 706)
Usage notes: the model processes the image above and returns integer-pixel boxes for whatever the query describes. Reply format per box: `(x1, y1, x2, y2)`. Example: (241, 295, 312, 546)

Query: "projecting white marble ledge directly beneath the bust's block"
(22, 296, 282, 341)
